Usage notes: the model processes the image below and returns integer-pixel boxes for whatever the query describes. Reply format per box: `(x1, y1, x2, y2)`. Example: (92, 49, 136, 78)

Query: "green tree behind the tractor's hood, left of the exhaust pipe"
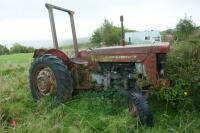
(91, 19, 121, 46)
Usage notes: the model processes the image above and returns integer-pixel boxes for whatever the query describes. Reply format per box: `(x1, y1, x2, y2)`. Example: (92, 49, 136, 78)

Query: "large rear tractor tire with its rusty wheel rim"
(29, 54, 73, 102)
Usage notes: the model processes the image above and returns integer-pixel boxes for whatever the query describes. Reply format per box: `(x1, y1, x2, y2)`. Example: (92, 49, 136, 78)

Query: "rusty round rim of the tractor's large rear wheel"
(36, 67, 57, 96)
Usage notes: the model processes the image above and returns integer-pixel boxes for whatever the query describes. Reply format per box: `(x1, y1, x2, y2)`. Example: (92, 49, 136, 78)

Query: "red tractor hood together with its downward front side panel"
(76, 43, 169, 86)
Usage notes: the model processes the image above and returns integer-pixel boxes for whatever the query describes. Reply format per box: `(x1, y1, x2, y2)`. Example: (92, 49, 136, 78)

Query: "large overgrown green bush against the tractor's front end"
(160, 38, 200, 110)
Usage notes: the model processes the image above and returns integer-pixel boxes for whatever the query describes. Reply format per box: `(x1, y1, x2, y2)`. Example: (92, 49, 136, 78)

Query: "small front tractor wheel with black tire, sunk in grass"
(128, 93, 153, 127)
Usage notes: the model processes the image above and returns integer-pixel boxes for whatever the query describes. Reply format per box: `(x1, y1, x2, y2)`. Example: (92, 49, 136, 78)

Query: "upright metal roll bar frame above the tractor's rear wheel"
(45, 3, 78, 57)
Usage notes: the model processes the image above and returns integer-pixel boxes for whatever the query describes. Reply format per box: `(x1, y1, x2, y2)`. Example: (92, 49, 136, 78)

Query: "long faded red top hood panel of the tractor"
(78, 42, 169, 61)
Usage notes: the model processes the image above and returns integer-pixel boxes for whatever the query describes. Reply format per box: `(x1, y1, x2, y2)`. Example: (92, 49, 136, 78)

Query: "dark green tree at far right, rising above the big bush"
(175, 17, 196, 40)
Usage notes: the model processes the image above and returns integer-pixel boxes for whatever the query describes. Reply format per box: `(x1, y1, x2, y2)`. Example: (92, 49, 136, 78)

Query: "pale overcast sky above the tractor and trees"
(0, 0, 200, 43)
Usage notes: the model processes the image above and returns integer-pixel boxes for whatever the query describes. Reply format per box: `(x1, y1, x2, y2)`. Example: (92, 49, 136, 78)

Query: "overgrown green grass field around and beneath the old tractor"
(0, 54, 200, 133)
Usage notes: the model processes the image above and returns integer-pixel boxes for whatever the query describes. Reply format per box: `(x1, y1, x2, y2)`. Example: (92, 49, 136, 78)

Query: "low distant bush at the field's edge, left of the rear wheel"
(10, 43, 34, 53)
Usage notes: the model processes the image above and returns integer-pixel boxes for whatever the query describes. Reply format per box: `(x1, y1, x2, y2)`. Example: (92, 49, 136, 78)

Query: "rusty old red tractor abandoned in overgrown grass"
(29, 4, 169, 126)
